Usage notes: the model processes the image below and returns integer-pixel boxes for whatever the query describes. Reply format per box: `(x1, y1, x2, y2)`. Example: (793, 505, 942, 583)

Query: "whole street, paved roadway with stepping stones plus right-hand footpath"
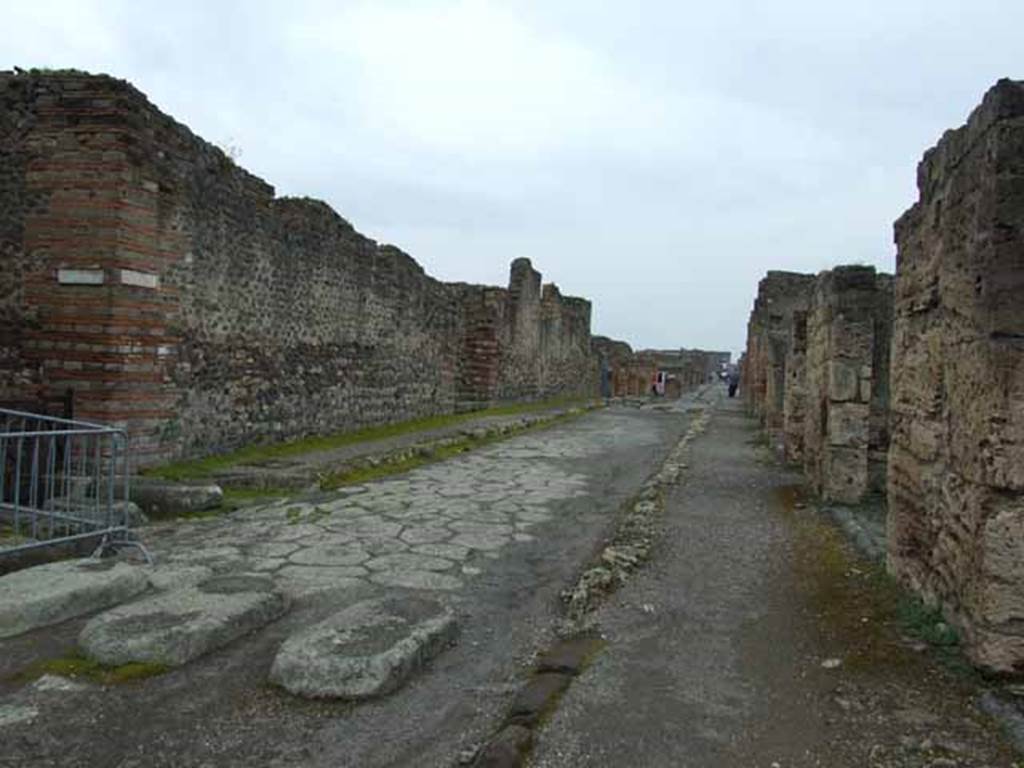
(0, 387, 1012, 768)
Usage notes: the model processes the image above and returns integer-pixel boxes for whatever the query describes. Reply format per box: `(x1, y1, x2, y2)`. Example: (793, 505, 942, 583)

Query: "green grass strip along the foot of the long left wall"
(143, 397, 588, 480)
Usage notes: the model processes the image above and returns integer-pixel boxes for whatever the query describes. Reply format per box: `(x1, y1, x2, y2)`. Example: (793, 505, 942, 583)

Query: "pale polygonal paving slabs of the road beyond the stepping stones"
(144, 427, 597, 601)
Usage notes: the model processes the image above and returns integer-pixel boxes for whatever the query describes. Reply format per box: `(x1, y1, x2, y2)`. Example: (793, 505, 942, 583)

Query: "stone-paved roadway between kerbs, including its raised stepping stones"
(0, 396, 699, 766)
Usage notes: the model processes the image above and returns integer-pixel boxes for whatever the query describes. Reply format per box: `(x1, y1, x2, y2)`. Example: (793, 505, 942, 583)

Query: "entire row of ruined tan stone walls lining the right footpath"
(742, 80, 1024, 673)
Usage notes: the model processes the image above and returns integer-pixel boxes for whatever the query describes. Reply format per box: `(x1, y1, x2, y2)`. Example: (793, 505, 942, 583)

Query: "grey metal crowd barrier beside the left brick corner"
(0, 409, 144, 558)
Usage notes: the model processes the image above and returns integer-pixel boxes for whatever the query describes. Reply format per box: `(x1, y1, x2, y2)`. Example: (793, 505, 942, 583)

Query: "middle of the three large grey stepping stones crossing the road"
(78, 573, 288, 667)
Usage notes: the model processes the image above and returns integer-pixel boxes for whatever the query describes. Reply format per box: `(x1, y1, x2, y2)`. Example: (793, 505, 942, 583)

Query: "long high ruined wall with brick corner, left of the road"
(0, 73, 598, 464)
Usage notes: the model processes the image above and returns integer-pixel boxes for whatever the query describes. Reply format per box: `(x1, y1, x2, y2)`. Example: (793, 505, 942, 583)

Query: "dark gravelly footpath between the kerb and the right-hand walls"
(530, 393, 1015, 768)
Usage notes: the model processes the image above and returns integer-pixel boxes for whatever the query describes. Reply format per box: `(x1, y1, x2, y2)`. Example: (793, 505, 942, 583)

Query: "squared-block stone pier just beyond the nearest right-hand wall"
(802, 266, 893, 504)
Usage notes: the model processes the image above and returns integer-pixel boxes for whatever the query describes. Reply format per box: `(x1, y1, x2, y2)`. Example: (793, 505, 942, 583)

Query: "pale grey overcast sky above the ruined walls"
(8, 0, 1024, 350)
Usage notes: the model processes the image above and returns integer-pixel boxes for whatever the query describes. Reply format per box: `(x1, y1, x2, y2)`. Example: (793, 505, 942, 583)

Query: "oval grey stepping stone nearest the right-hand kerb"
(270, 595, 456, 699)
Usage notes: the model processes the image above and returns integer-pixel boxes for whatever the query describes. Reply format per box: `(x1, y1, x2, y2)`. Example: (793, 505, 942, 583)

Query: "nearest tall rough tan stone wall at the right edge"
(889, 75, 1024, 672)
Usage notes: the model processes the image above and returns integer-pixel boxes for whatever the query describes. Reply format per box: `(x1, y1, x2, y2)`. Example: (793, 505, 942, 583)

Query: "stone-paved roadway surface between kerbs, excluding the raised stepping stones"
(0, 399, 687, 768)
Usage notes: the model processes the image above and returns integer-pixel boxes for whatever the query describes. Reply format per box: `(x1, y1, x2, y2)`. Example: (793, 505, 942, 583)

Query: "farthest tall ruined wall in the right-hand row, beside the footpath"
(740, 271, 814, 443)
